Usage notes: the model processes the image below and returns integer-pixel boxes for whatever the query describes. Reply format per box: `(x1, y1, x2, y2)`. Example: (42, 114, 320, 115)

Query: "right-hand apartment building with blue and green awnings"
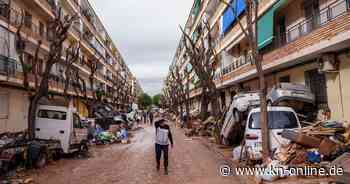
(171, 0, 350, 120)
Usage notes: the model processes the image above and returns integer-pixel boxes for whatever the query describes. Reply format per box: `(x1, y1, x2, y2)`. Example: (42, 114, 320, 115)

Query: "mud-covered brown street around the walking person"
(22, 123, 243, 184)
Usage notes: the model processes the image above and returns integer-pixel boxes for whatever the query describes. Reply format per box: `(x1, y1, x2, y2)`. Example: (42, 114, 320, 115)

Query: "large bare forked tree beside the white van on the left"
(15, 9, 76, 139)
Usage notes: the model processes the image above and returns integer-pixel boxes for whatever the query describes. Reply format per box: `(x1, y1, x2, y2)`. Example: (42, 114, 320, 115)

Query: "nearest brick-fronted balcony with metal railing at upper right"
(263, 0, 350, 64)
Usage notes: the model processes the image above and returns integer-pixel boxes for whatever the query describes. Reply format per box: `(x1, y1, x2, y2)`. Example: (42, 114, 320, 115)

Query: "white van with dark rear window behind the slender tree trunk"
(245, 107, 301, 160)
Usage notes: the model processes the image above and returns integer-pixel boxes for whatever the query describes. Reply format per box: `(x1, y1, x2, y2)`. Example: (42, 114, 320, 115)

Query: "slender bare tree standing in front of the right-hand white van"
(220, 0, 270, 159)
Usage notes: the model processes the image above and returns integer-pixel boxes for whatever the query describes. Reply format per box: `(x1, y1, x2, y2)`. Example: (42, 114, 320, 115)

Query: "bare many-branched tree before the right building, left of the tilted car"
(180, 21, 221, 120)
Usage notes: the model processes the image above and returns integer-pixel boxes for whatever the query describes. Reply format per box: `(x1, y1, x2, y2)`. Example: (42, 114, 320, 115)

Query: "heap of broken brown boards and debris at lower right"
(274, 121, 350, 164)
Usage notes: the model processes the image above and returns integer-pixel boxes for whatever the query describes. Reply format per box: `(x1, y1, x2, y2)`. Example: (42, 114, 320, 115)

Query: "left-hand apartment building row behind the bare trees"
(0, 0, 136, 133)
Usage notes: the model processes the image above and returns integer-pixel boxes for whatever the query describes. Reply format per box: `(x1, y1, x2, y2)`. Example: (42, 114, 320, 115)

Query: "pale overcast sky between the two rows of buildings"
(90, 0, 193, 95)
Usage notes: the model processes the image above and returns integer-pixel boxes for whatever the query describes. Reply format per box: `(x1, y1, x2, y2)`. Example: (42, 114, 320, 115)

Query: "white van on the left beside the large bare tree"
(35, 105, 88, 153)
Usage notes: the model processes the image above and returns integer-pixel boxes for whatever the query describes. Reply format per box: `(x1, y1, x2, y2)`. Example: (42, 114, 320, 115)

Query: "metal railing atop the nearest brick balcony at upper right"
(275, 0, 350, 47)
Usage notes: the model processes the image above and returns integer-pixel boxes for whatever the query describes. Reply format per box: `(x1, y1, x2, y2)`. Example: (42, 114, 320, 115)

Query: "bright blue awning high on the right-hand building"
(222, 0, 246, 33)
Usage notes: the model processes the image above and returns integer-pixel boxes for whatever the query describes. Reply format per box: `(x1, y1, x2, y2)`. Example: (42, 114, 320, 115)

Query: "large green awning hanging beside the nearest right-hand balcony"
(258, 0, 287, 49)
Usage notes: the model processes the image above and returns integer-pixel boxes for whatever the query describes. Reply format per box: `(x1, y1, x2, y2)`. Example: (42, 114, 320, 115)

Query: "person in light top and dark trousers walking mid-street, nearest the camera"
(154, 119, 174, 175)
